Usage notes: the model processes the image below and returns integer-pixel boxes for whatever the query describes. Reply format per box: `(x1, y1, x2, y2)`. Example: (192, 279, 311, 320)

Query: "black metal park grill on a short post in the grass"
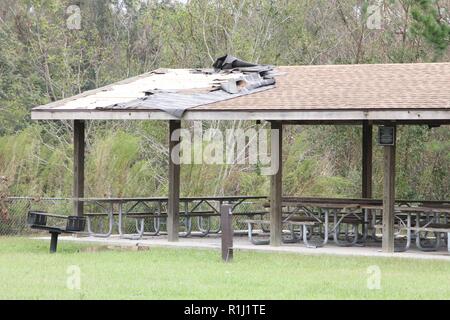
(27, 211, 86, 253)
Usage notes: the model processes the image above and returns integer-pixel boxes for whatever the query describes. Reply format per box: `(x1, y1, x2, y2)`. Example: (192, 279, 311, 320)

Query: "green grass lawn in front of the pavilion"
(0, 238, 450, 299)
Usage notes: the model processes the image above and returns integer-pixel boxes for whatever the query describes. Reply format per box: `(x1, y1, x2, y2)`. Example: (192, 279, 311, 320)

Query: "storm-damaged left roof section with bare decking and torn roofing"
(33, 55, 275, 118)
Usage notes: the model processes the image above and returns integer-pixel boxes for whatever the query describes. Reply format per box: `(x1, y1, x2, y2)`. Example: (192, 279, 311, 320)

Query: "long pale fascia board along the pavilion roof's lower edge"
(31, 109, 450, 125)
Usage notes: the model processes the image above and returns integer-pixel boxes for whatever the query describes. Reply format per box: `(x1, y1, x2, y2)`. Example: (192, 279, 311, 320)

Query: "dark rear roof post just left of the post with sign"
(361, 120, 372, 198)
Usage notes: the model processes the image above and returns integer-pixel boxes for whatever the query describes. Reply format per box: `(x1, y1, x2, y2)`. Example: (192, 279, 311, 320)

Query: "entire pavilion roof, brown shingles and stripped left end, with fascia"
(32, 56, 450, 121)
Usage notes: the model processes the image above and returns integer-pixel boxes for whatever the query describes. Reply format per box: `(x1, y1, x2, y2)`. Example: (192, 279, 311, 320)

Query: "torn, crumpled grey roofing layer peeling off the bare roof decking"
(96, 55, 275, 118)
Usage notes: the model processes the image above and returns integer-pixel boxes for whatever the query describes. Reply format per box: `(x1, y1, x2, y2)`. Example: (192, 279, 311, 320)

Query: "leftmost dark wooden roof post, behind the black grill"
(72, 120, 85, 217)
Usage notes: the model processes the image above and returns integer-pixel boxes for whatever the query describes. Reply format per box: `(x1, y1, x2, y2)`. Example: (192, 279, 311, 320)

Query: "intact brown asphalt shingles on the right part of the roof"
(191, 63, 450, 111)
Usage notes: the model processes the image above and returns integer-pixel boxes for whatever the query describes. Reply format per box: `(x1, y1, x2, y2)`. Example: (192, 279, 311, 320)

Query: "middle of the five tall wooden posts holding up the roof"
(270, 121, 283, 246)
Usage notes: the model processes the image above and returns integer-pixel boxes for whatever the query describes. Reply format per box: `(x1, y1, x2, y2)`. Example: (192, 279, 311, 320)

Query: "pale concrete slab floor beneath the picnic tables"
(34, 236, 450, 262)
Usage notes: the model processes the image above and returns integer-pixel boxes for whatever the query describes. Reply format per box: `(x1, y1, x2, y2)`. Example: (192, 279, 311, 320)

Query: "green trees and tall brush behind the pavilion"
(0, 0, 450, 199)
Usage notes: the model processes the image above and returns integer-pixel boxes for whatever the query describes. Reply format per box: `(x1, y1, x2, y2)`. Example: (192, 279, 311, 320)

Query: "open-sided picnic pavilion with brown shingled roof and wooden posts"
(32, 63, 450, 252)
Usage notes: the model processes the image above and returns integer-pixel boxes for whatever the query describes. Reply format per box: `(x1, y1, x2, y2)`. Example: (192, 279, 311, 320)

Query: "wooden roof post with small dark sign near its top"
(382, 129, 395, 252)
